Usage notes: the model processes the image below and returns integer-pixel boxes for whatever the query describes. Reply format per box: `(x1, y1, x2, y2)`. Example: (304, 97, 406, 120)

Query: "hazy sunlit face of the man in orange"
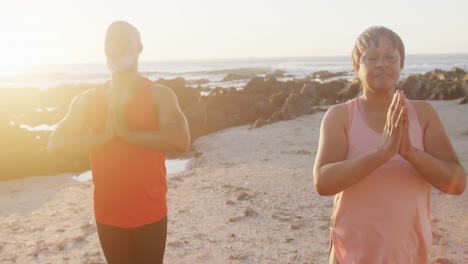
(104, 28, 141, 73)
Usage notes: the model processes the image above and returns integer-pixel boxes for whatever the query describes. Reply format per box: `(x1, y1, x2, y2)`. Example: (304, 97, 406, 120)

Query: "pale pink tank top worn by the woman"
(331, 98, 432, 264)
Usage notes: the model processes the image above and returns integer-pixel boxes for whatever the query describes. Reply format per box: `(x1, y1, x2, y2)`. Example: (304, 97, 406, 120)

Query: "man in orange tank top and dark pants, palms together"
(48, 21, 190, 264)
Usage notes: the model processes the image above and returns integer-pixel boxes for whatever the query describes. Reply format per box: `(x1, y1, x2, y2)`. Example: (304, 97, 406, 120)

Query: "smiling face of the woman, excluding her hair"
(356, 36, 401, 92)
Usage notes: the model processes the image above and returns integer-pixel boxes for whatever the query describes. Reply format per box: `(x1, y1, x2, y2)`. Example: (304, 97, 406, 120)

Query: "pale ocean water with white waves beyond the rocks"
(0, 54, 468, 89)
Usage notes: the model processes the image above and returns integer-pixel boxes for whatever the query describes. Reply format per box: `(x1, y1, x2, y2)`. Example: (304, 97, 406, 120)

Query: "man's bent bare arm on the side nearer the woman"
(116, 85, 190, 152)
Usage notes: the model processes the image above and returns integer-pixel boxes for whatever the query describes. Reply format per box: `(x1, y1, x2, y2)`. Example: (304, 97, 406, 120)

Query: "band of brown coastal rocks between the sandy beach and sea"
(0, 68, 468, 180)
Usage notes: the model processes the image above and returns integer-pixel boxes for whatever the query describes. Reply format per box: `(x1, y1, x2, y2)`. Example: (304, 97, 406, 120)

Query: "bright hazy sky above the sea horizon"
(0, 0, 468, 68)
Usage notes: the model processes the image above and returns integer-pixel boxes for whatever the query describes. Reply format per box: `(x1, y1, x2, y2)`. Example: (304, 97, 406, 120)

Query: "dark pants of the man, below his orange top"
(96, 217, 167, 264)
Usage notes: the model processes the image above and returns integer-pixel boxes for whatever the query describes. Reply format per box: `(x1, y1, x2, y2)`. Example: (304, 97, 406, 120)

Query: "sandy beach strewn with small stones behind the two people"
(0, 100, 468, 264)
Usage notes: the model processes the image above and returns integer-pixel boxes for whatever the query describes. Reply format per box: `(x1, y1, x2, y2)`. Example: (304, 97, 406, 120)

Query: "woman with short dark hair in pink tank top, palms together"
(314, 27, 466, 264)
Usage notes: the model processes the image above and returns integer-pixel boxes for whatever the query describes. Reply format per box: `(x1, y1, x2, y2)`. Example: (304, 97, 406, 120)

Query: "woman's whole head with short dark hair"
(352, 26, 405, 94)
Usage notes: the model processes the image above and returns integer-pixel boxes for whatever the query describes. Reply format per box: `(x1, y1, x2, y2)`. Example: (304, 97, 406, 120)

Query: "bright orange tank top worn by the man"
(87, 80, 167, 228)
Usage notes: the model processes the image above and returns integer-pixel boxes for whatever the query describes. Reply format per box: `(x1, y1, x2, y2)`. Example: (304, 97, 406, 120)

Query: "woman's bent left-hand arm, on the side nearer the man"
(314, 95, 406, 195)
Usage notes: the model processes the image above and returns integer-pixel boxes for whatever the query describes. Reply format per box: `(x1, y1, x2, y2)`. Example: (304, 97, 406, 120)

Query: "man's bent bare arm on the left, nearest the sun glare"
(47, 89, 113, 157)
